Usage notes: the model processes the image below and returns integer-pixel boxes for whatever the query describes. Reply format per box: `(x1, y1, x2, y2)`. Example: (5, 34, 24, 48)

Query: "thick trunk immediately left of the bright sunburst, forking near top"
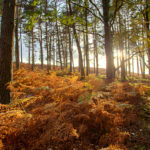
(102, 0, 115, 80)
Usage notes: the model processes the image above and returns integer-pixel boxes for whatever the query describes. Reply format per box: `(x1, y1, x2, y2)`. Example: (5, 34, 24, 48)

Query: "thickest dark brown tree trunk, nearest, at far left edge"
(0, 0, 16, 104)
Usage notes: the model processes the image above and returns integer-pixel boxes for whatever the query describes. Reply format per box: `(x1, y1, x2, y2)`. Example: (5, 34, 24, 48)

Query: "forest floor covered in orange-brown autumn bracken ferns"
(0, 63, 150, 150)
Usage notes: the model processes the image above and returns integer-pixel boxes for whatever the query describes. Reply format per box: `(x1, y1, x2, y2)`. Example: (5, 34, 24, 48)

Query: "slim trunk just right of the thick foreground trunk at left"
(15, 0, 20, 70)
